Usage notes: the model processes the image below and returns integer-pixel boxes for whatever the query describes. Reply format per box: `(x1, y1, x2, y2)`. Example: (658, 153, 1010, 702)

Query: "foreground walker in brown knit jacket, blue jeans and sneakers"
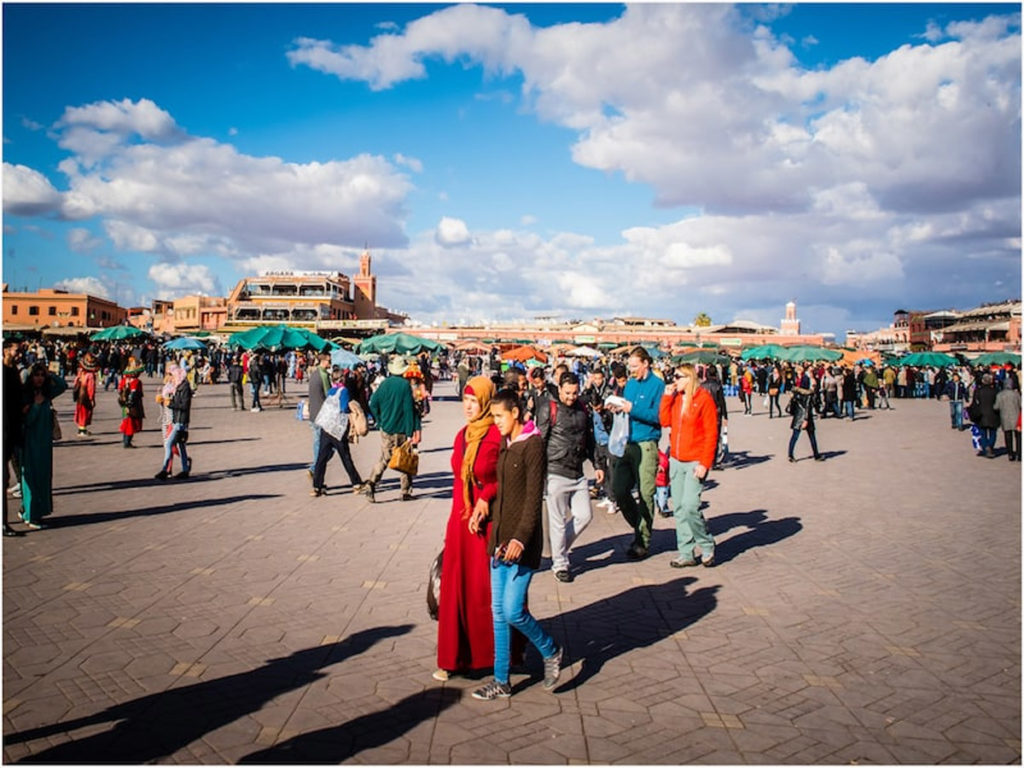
(469, 389, 562, 700)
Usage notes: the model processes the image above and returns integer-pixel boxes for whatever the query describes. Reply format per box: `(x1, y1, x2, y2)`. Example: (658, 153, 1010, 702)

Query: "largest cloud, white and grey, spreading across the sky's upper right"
(289, 3, 1021, 219)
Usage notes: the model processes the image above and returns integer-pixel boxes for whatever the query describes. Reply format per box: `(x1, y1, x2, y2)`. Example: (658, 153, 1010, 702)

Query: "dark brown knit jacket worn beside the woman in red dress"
(487, 434, 545, 570)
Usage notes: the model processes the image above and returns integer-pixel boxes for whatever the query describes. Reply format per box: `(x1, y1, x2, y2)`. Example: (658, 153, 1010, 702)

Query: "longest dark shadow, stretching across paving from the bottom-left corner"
(4, 625, 413, 764)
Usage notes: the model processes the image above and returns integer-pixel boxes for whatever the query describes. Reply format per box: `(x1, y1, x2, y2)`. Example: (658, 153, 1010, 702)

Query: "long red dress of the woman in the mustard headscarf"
(437, 426, 502, 672)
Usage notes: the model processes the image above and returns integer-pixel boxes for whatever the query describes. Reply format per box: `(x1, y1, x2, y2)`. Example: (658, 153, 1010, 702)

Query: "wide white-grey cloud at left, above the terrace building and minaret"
(4, 99, 413, 280)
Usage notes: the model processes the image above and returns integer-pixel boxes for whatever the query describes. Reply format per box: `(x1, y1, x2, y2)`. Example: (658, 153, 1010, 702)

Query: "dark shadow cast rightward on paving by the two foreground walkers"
(552, 577, 719, 693)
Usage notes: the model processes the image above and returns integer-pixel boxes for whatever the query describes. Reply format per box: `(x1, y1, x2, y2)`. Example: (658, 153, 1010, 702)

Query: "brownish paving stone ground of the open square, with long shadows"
(3, 379, 1021, 764)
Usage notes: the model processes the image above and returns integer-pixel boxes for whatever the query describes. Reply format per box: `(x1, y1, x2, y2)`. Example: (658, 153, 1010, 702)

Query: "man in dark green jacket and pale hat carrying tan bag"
(360, 356, 420, 502)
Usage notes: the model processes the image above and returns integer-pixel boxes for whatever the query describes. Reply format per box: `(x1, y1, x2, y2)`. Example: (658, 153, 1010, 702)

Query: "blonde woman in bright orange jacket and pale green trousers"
(658, 365, 718, 568)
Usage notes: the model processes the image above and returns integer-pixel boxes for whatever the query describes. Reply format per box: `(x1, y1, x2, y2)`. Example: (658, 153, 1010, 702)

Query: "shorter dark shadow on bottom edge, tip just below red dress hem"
(239, 687, 462, 765)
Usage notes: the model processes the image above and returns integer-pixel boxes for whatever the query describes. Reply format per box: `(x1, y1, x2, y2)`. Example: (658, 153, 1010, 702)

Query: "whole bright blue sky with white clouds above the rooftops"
(3, 3, 1021, 337)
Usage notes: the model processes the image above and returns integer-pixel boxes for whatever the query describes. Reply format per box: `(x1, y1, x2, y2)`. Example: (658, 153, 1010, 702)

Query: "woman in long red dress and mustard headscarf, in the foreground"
(434, 376, 501, 680)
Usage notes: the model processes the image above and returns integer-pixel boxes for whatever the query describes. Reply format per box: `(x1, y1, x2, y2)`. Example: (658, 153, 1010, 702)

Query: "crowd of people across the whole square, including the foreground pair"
(3, 331, 1021, 699)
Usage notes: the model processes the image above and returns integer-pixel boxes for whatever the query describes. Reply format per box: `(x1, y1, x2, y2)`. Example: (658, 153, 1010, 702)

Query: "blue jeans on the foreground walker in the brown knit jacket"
(490, 558, 558, 685)
